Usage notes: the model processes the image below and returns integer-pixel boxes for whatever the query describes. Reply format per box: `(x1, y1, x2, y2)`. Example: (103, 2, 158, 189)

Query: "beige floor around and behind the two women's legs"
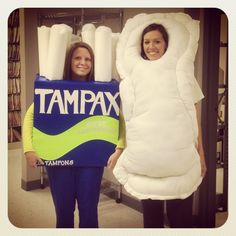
(8, 150, 227, 228)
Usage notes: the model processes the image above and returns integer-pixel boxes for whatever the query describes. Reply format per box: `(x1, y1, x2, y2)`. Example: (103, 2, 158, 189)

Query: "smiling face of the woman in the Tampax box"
(71, 47, 92, 81)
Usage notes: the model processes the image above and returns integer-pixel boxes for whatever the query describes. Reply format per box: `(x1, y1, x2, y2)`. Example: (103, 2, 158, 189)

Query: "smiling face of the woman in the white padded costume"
(142, 30, 166, 61)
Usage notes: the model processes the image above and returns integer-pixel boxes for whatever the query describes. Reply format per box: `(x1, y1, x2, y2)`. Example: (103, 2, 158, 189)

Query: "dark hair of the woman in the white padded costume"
(141, 23, 169, 60)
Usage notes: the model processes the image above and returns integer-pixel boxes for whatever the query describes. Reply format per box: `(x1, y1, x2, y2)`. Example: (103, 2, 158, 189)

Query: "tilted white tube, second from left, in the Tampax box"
(46, 25, 72, 80)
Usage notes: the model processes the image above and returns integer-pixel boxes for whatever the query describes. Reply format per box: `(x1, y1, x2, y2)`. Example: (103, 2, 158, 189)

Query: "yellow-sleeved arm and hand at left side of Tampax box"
(22, 104, 43, 167)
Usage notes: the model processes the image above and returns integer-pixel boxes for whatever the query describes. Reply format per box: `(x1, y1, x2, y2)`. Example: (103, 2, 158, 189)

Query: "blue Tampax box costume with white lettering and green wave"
(33, 76, 120, 166)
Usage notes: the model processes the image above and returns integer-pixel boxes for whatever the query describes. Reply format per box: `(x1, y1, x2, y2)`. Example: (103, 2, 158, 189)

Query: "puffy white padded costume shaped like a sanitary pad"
(113, 13, 203, 200)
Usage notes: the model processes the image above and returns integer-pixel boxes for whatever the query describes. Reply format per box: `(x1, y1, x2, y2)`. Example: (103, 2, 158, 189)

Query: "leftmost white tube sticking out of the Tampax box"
(38, 26, 50, 76)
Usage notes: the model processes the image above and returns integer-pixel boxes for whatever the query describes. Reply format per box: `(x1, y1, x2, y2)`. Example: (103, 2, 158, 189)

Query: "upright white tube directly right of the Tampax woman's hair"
(94, 26, 112, 82)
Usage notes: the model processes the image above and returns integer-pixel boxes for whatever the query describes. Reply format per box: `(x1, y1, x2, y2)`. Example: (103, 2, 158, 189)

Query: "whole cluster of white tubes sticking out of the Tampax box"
(38, 24, 119, 82)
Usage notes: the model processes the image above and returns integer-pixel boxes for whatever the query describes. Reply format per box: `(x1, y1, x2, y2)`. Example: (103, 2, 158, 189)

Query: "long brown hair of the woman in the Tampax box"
(64, 42, 94, 81)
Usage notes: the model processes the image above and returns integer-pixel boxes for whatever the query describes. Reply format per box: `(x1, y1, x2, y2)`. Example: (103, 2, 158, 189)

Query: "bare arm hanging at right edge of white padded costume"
(195, 106, 207, 177)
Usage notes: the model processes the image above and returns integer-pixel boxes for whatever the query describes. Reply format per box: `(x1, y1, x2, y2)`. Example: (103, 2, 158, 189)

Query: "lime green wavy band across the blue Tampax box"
(33, 116, 119, 160)
